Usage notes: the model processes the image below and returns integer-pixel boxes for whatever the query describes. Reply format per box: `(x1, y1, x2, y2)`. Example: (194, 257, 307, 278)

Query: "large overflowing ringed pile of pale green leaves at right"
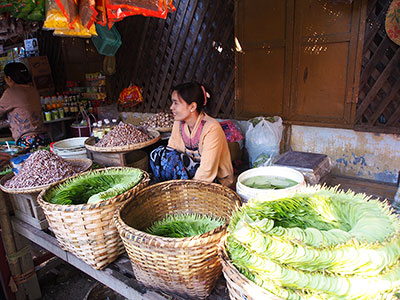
(226, 186, 400, 300)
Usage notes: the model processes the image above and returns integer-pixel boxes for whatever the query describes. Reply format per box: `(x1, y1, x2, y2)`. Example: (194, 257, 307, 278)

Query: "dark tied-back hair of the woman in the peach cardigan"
(172, 82, 210, 112)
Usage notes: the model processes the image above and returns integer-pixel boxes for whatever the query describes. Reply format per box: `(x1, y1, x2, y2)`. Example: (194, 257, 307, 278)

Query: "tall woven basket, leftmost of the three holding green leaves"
(38, 167, 150, 269)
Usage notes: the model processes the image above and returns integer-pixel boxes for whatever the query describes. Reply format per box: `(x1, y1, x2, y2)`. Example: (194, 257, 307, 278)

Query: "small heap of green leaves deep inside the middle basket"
(146, 213, 225, 238)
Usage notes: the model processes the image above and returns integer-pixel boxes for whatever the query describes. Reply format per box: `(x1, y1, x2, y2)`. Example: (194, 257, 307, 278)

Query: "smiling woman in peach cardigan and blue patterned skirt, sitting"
(150, 82, 234, 186)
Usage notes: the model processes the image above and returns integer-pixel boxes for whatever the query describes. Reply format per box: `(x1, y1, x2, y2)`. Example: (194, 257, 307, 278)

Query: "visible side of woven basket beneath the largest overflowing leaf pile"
(218, 236, 283, 300)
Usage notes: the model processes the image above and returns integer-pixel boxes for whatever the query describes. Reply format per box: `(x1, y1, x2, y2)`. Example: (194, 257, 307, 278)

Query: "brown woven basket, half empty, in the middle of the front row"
(114, 180, 241, 299)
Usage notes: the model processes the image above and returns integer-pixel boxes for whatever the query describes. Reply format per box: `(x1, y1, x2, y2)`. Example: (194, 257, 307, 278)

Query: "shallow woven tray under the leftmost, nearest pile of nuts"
(0, 158, 93, 194)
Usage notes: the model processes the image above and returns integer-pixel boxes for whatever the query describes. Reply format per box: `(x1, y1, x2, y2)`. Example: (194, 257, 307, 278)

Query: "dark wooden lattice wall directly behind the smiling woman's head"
(108, 0, 235, 118)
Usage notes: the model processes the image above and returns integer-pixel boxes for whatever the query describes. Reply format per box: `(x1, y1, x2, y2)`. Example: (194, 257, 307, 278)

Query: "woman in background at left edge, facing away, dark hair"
(0, 62, 50, 151)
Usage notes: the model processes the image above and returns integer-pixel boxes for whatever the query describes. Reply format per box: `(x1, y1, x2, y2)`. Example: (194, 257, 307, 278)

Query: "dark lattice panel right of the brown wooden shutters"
(355, 0, 400, 133)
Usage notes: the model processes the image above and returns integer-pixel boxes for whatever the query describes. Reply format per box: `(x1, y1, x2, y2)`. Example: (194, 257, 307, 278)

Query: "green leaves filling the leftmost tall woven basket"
(43, 168, 143, 204)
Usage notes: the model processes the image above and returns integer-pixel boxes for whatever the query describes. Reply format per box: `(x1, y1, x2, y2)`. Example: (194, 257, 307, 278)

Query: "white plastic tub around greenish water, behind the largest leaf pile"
(236, 166, 306, 202)
